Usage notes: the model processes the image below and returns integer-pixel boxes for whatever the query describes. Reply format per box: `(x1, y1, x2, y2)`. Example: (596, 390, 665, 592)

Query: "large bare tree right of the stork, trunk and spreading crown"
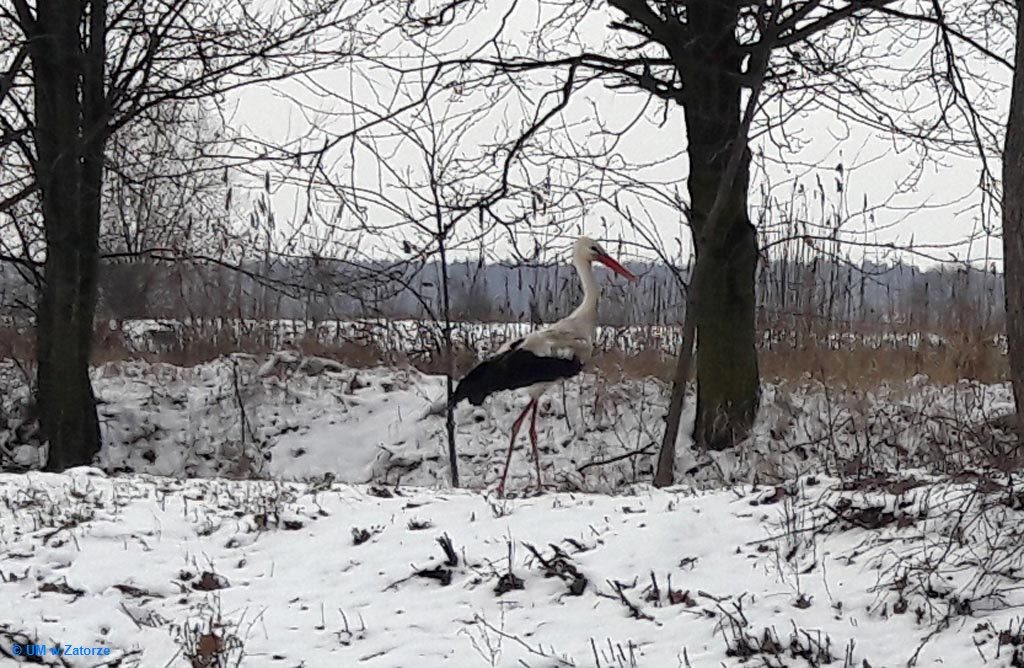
(387, 0, 987, 467)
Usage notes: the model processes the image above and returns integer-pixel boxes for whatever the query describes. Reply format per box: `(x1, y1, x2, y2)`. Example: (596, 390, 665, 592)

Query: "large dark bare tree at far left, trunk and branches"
(0, 0, 376, 470)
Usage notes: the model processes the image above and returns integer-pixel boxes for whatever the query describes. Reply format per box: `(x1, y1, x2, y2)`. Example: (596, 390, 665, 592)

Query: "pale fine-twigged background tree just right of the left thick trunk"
(99, 100, 230, 320)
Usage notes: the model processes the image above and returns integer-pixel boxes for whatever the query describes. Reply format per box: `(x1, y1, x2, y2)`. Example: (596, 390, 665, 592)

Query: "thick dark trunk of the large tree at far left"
(32, 0, 105, 471)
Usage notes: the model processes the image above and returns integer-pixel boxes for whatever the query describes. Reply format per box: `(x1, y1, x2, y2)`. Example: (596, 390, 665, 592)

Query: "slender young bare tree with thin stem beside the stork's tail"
(288, 66, 593, 487)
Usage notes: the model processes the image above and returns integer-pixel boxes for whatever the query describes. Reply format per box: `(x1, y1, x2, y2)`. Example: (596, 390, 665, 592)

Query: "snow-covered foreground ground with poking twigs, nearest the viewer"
(6, 469, 1024, 668)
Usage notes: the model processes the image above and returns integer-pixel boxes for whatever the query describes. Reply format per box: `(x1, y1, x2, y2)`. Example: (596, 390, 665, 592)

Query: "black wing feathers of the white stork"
(452, 339, 583, 406)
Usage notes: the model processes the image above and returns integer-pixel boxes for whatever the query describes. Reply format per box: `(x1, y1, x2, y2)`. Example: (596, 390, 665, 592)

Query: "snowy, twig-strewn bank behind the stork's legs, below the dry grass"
(0, 353, 1015, 493)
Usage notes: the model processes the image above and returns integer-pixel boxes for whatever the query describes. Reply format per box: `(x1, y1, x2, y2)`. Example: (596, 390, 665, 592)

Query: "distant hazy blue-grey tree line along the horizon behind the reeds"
(0, 254, 1005, 330)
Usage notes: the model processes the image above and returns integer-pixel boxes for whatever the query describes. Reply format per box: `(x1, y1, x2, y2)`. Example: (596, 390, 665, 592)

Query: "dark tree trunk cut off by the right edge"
(1002, 3, 1024, 432)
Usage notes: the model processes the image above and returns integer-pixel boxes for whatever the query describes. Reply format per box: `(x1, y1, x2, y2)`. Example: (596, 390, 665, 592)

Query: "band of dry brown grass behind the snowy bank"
(0, 315, 1009, 389)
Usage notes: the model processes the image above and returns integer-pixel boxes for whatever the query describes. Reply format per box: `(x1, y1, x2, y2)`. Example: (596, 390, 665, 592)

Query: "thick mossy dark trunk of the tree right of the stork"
(679, 0, 760, 450)
